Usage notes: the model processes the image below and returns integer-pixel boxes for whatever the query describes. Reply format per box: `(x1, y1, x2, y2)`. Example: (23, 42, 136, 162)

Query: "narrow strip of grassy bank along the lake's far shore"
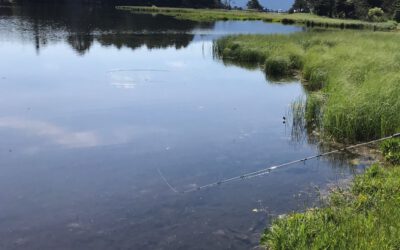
(117, 6, 397, 30)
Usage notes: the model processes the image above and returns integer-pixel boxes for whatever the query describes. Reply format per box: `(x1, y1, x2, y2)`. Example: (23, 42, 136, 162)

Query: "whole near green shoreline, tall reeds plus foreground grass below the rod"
(216, 31, 400, 249)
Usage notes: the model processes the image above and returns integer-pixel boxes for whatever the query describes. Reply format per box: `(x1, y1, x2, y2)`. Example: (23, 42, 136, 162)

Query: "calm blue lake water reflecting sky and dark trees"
(0, 6, 360, 250)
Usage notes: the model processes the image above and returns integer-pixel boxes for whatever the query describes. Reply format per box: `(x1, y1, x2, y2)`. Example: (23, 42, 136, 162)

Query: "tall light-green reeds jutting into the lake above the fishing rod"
(216, 31, 400, 142)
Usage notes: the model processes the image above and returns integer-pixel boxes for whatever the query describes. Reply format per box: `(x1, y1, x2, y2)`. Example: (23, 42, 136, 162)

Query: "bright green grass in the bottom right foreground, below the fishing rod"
(261, 139, 400, 250)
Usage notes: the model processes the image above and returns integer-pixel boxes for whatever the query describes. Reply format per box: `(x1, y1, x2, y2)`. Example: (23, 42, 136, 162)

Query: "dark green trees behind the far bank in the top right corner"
(291, 0, 400, 21)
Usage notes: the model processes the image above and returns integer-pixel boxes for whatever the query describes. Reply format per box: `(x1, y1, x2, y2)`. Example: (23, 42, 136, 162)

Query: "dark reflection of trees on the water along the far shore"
(0, 4, 213, 54)
